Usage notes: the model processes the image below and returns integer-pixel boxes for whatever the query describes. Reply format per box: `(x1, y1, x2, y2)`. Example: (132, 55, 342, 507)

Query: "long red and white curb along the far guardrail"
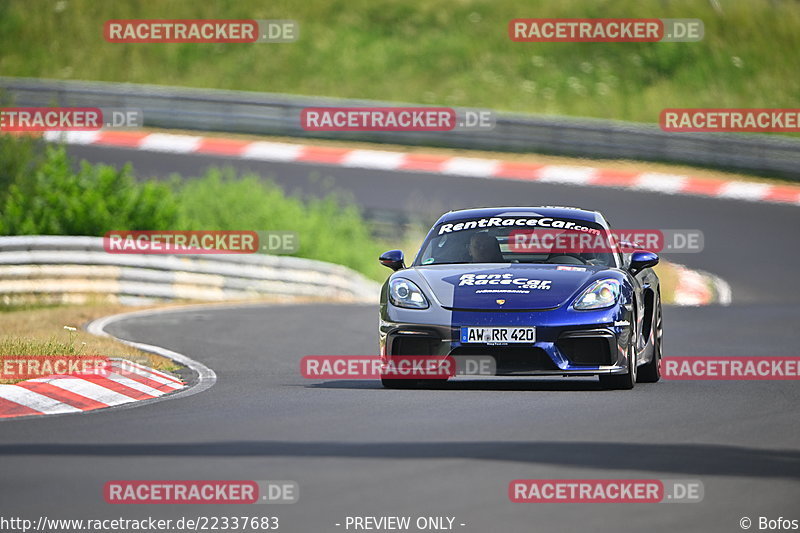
(44, 130, 800, 205)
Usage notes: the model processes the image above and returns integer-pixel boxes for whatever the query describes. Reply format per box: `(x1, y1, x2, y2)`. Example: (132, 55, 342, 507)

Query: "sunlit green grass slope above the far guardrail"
(0, 0, 800, 122)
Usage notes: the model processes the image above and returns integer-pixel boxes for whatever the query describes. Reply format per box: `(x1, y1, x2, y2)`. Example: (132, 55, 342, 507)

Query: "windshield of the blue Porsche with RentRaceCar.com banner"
(415, 217, 617, 266)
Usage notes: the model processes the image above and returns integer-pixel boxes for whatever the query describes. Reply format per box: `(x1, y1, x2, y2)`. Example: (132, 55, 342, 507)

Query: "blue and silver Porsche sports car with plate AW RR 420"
(379, 207, 663, 389)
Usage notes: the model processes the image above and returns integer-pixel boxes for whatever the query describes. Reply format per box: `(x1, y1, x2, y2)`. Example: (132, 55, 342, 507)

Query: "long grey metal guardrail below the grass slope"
(0, 77, 800, 180)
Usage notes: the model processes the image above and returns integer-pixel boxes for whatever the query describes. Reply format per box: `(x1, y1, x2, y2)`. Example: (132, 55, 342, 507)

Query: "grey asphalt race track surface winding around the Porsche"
(0, 142, 800, 533)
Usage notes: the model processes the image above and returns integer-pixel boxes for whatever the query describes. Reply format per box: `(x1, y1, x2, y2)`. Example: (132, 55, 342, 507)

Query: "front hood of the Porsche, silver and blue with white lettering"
(414, 264, 608, 310)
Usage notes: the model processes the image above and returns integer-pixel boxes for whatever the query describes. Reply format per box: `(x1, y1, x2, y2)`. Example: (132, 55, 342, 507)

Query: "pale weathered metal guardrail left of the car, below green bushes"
(0, 236, 379, 302)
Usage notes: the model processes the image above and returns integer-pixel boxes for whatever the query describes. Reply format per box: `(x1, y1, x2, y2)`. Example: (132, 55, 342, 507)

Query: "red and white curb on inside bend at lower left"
(0, 359, 186, 418)
